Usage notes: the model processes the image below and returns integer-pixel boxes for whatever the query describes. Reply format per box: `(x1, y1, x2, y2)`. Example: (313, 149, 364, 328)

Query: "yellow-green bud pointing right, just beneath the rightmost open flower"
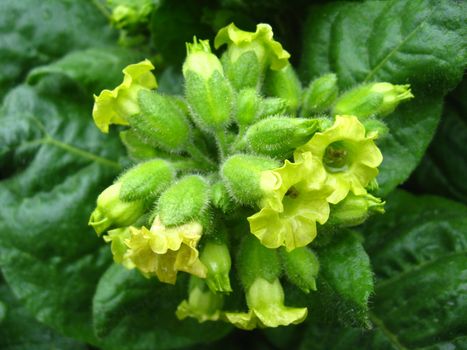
(329, 193, 385, 227)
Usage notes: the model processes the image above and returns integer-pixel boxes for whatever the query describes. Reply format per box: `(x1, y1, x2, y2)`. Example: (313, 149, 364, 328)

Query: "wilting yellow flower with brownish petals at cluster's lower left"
(125, 217, 206, 284)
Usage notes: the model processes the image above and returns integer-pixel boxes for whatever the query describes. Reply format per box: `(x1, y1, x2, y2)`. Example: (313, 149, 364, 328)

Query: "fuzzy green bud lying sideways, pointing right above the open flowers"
(246, 117, 319, 159)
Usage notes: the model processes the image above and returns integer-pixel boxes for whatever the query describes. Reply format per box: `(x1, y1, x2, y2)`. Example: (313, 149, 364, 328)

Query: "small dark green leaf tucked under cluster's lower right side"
(317, 231, 373, 327)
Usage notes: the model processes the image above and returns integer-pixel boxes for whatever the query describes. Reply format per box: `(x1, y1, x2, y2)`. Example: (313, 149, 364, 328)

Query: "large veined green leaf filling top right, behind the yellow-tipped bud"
(301, 0, 467, 195)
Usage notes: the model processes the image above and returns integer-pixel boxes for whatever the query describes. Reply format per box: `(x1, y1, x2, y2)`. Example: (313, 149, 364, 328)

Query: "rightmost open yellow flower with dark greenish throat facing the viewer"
(294, 115, 383, 204)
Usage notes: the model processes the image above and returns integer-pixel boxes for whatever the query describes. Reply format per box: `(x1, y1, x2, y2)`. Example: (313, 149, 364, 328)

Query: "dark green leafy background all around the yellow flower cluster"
(0, 0, 467, 350)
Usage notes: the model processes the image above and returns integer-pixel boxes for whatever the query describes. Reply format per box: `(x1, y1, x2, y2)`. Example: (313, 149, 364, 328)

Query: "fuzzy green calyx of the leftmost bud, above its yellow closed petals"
(119, 159, 175, 201)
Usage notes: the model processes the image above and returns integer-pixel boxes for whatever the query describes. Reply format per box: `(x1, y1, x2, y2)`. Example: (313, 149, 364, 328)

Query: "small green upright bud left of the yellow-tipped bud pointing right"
(302, 73, 339, 117)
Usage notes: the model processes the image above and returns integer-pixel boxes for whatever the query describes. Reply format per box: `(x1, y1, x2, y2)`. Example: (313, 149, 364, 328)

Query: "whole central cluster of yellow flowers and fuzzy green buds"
(89, 24, 413, 329)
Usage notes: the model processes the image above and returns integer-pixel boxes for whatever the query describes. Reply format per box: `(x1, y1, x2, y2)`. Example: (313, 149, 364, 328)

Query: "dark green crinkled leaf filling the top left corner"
(0, 0, 113, 100)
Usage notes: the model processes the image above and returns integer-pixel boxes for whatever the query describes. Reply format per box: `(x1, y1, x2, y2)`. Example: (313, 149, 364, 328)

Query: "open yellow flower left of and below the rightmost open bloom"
(248, 152, 330, 251)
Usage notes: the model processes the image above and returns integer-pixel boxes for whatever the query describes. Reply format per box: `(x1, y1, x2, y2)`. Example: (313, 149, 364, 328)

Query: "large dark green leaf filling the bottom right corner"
(302, 191, 467, 349)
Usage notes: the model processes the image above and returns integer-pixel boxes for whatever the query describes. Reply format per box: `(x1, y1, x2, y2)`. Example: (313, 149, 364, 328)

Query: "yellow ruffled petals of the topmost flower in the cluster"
(214, 23, 290, 70)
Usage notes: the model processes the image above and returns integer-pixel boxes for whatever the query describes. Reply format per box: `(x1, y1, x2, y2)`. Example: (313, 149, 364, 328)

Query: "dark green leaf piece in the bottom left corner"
(0, 275, 87, 350)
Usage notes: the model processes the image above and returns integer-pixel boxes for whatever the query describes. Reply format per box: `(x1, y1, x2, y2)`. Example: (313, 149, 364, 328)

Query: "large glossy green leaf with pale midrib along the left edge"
(0, 81, 122, 342)
